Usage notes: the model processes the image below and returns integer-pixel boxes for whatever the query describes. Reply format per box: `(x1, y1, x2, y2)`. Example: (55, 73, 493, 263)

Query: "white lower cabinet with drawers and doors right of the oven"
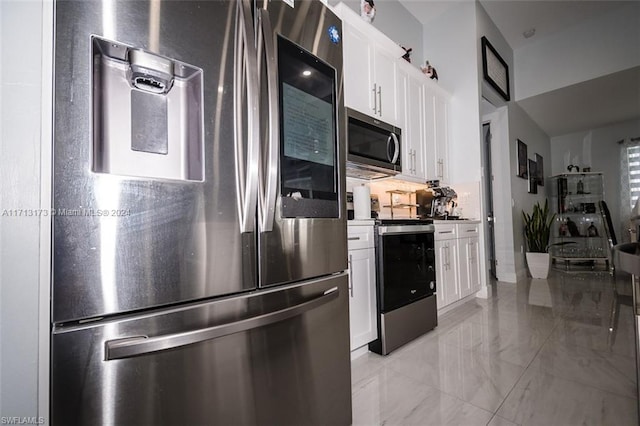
(435, 222, 481, 309)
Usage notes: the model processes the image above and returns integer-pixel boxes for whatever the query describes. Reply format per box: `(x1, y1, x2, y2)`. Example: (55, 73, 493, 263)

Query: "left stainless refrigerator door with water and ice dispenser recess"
(52, 0, 259, 323)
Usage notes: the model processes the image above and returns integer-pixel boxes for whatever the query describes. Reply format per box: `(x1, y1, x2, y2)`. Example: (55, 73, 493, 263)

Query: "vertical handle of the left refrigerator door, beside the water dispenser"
(233, 0, 260, 232)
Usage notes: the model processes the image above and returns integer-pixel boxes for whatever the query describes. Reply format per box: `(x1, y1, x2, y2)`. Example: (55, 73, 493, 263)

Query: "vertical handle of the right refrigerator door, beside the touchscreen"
(258, 9, 280, 232)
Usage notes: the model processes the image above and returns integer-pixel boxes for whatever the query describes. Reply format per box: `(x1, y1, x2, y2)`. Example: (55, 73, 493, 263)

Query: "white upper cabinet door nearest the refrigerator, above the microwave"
(343, 22, 374, 115)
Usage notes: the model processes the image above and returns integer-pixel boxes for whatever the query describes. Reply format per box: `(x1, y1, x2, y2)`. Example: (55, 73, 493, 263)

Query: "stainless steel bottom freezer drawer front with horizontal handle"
(51, 274, 351, 425)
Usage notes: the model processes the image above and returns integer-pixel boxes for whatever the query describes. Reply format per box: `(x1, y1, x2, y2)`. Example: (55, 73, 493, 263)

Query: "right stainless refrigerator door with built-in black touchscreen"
(256, 0, 347, 286)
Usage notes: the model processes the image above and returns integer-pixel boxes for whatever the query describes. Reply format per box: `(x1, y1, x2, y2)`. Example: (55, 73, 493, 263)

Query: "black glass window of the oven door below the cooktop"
(380, 233, 436, 312)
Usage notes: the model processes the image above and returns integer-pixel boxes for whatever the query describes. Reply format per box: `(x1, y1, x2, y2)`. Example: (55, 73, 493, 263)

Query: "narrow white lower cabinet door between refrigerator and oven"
(349, 248, 378, 350)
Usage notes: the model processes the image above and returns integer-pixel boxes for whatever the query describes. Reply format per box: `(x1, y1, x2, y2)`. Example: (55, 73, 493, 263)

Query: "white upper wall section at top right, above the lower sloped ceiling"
(514, 1, 640, 100)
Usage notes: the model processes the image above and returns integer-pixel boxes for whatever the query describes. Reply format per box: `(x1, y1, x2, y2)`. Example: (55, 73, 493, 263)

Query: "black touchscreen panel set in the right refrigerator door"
(278, 37, 340, 218)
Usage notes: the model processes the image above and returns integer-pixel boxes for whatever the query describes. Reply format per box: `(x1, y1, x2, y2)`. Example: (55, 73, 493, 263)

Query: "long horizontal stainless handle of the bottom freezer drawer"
(105, 287, 340, 361)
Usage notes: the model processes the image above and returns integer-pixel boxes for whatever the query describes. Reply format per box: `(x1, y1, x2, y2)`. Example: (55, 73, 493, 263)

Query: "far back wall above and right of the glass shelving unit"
(551, 120, 640, 240)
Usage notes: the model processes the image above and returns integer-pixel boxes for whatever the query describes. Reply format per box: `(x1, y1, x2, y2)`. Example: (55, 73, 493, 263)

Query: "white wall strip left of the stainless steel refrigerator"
(0, 0, 52, 420)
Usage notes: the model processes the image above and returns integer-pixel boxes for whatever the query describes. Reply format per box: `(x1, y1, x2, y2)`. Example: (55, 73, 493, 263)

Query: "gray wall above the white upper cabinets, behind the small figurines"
(329, 0, 424, 67)
